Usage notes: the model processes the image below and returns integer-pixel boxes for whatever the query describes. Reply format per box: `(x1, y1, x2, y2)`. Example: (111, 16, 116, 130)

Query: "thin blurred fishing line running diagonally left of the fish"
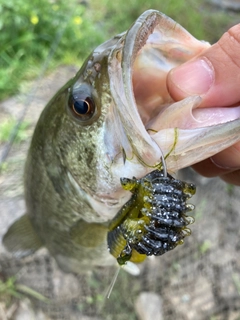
(0, 12, 73, 172)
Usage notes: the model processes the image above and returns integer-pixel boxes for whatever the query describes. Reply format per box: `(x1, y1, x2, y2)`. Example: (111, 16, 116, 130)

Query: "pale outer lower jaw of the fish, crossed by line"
(152, 119, 240, 172)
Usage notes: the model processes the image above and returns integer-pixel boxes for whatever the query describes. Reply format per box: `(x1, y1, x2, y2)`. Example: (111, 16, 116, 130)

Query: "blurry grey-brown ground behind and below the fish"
(0, 67, 240, 320)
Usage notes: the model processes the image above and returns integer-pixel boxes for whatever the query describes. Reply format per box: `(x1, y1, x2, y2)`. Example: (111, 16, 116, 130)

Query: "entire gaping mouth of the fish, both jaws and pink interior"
(109, 10, 240, 171)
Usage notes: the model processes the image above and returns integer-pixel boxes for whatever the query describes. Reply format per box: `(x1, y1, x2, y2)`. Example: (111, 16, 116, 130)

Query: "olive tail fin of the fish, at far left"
(3, 214, 42, 258)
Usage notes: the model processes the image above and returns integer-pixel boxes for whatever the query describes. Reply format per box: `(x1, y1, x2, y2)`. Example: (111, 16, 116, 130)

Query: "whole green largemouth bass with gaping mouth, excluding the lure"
(4, 10, 240, 273)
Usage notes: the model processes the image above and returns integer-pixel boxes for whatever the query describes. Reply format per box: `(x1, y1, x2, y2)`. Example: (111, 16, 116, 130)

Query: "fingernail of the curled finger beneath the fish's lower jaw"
(211, 146, 240, 170)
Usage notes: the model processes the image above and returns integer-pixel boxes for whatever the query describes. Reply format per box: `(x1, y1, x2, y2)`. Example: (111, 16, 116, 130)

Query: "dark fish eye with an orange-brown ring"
(68, 93, 95, 121)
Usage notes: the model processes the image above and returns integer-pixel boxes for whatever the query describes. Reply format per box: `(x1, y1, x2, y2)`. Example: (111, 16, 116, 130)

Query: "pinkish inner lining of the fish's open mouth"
(132, 13, 240, 134)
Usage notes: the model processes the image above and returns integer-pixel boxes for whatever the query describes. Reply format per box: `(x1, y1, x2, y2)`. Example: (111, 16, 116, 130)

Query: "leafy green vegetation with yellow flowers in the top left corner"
(0, 0, 103, 99)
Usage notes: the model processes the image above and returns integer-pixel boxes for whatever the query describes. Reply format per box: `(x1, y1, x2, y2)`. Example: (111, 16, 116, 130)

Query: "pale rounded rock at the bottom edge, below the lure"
(135, 292, 163, 320)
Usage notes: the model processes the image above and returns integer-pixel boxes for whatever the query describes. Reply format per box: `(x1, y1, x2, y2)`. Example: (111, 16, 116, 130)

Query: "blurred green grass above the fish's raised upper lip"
(91, 0, 239, 42)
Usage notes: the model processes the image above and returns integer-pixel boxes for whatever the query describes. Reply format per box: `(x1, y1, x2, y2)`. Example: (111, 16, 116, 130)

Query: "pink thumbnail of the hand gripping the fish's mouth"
(171, 59, 214, 94)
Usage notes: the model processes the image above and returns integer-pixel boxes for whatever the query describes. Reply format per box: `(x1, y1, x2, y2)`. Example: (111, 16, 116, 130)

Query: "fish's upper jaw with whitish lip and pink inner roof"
(108, 10, 209, 167)
